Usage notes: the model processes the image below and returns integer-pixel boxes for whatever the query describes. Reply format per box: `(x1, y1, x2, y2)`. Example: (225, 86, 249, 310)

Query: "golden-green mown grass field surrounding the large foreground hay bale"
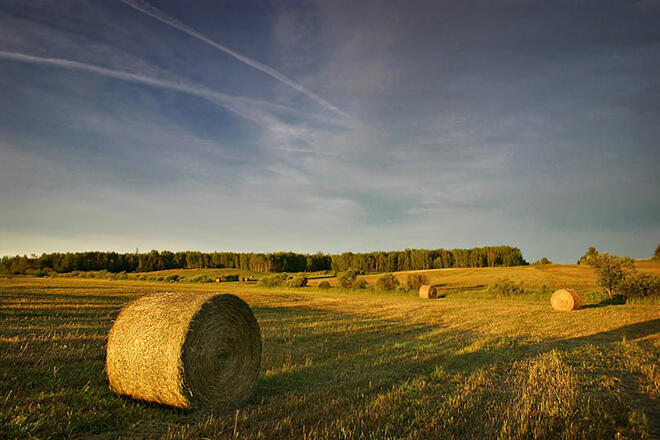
(0, 277, 660, 439)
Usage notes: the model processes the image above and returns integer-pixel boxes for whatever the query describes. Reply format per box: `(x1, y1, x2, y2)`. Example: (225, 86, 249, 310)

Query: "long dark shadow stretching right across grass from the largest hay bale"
(253, 306, 660, 402)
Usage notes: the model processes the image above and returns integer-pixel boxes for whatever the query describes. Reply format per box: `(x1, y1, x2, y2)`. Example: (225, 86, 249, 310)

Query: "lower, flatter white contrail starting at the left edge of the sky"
(0, 51, 310, 143)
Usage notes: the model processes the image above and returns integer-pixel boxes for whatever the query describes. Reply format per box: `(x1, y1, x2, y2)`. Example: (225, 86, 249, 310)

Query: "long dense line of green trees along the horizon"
(0, 246, 527, 274)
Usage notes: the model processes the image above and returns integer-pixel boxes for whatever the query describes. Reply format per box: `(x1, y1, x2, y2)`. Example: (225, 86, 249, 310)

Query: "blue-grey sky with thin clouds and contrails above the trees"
(0, 0, 660, 263)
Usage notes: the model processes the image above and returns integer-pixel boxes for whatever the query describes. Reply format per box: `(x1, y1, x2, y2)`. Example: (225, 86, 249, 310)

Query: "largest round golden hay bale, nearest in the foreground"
(106, 293, 261, 408)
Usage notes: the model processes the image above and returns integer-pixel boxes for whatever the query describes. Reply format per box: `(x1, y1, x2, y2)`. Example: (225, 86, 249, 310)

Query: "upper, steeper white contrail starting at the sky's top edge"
(121, 0, 349, 117)
